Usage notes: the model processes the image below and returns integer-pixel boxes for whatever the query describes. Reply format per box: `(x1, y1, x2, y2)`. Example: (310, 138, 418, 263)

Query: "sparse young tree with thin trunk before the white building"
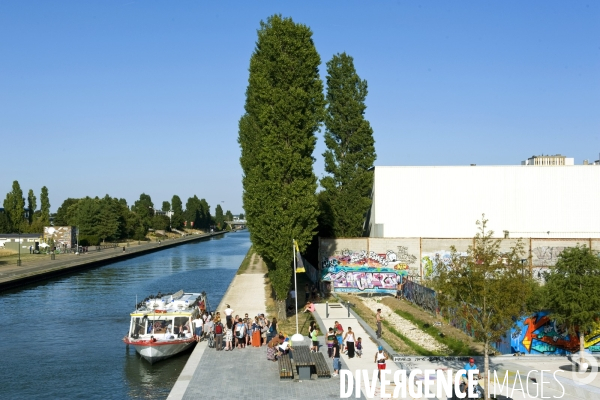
(433, 216, 531, 388)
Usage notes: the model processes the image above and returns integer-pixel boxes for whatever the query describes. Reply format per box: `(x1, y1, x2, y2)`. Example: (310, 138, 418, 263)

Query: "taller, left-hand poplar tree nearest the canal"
(238, 15, 325, 315)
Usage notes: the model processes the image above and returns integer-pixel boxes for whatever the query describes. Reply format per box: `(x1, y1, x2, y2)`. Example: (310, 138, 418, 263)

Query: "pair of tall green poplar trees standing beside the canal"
(238, 15, 376, 311)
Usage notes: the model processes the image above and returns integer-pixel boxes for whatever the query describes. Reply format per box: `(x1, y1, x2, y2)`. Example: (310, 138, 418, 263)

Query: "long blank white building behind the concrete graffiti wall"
(367, 165, 600, 238)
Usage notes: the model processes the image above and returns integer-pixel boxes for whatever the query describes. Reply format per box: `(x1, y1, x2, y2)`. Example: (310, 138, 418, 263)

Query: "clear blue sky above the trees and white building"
(0, 0, 600, 213)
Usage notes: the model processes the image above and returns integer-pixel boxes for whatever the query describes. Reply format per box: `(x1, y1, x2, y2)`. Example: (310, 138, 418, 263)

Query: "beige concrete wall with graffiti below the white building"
(319, 238, 600, 293)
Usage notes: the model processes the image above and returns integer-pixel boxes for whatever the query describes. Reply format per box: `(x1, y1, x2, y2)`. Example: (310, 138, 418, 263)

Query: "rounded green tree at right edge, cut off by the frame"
(544, 245, 600, 368)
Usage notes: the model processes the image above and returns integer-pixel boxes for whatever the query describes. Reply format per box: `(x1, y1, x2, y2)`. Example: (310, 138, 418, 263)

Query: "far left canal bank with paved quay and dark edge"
(0, 231, 227, 292)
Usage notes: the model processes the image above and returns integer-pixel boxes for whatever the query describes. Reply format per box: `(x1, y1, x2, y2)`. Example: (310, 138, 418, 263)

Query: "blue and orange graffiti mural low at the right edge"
(496, 311, 600, 355)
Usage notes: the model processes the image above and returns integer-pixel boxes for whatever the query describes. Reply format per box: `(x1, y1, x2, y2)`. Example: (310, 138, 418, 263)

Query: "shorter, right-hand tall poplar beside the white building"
(320, 53, 376, 237)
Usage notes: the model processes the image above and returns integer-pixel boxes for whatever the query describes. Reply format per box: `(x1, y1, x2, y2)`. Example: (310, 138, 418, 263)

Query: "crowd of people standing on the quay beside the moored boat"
(192, 304, 277, 351)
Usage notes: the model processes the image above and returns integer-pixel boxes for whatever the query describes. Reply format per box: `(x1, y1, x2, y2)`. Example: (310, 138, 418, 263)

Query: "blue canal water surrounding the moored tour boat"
(0, 231, 250, 399)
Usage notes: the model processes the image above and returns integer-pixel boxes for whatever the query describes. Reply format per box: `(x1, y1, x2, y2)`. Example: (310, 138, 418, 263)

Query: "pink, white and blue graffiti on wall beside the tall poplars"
(321, 246, 417, 293)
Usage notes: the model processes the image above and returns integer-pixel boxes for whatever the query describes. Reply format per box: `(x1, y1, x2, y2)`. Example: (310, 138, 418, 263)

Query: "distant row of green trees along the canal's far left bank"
(0, 181, 233, 244)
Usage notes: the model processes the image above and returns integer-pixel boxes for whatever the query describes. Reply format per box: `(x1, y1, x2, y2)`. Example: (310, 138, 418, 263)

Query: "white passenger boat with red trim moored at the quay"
(123, 290, 207, 364)
